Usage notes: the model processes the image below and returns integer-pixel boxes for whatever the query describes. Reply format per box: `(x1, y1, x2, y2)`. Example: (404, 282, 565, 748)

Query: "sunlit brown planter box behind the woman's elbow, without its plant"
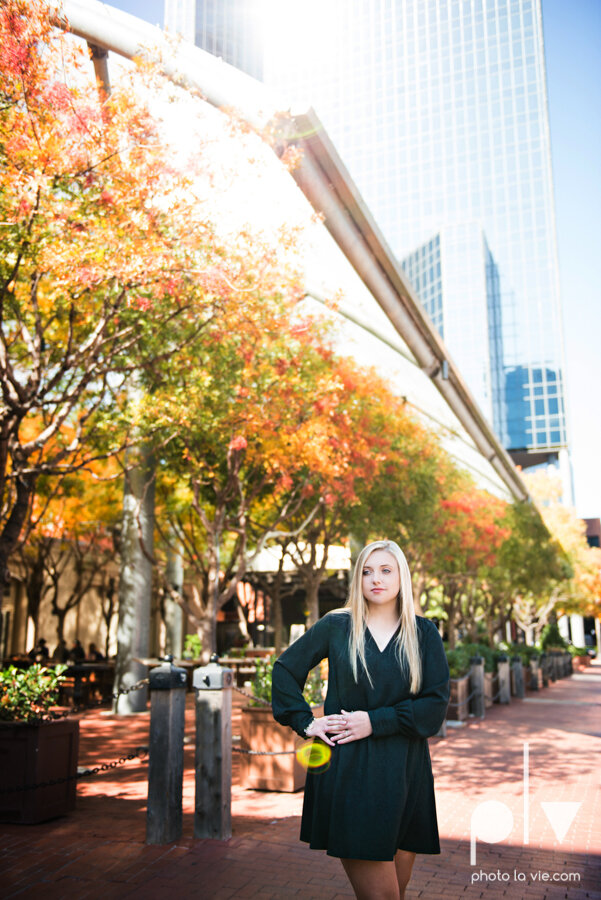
(240, 706, 323, 793)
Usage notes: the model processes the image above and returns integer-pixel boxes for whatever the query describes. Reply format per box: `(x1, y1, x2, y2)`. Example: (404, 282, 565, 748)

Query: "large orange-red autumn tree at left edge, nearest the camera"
(0, 0, 239, 604)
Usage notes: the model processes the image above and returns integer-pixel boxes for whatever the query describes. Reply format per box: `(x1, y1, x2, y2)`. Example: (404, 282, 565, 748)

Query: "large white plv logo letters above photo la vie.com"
(470, 743, 582, 866)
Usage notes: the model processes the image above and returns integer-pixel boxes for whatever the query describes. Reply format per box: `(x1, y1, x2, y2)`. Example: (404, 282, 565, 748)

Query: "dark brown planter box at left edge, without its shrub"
(0, 719, 79, 825)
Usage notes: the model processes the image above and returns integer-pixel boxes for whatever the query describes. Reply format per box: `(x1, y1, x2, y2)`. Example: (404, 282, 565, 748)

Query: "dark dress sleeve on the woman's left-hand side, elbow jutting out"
(271, 615, 330, 737)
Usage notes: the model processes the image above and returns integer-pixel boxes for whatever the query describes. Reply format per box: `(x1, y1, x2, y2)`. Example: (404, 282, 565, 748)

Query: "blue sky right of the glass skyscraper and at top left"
(104, 0, 601, 518)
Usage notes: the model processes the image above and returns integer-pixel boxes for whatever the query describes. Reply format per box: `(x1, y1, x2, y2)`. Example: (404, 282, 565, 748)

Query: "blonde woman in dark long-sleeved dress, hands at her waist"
(272, 541, 449, 900)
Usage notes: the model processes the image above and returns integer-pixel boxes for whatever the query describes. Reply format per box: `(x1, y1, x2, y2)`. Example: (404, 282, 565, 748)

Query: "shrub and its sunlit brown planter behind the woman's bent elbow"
(240, 654, 323, 792)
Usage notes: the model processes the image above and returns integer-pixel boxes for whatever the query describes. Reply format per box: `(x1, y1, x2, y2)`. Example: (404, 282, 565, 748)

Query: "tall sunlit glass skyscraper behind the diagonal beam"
(166, 0, 567, 465)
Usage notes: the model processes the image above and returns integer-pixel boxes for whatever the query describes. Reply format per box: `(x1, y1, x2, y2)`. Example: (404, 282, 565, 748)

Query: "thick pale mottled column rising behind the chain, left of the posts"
(114, 445, 154, 715)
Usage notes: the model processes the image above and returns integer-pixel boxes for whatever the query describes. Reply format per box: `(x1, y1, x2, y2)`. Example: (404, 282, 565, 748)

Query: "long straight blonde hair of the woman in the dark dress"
(344, 541, 422, 694)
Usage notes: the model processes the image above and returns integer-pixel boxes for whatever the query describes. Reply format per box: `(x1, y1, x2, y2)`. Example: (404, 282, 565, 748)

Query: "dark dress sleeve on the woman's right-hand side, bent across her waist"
(368, 623, 450, 738)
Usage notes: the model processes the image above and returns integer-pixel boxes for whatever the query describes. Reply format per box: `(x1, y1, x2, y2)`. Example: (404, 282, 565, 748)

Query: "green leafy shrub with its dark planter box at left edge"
(0, 664, 79, 824)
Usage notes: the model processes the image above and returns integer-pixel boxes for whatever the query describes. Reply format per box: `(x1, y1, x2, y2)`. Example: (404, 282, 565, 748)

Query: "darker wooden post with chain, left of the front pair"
(146, 659, 187, 844)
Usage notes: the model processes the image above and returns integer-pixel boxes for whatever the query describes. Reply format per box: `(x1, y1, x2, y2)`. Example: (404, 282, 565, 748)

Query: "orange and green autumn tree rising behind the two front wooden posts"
(148, 306, 331, 647)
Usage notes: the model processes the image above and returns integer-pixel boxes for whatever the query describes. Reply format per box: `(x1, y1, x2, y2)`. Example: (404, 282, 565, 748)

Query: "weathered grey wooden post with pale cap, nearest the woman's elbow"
(193, 654, 234, 841)
